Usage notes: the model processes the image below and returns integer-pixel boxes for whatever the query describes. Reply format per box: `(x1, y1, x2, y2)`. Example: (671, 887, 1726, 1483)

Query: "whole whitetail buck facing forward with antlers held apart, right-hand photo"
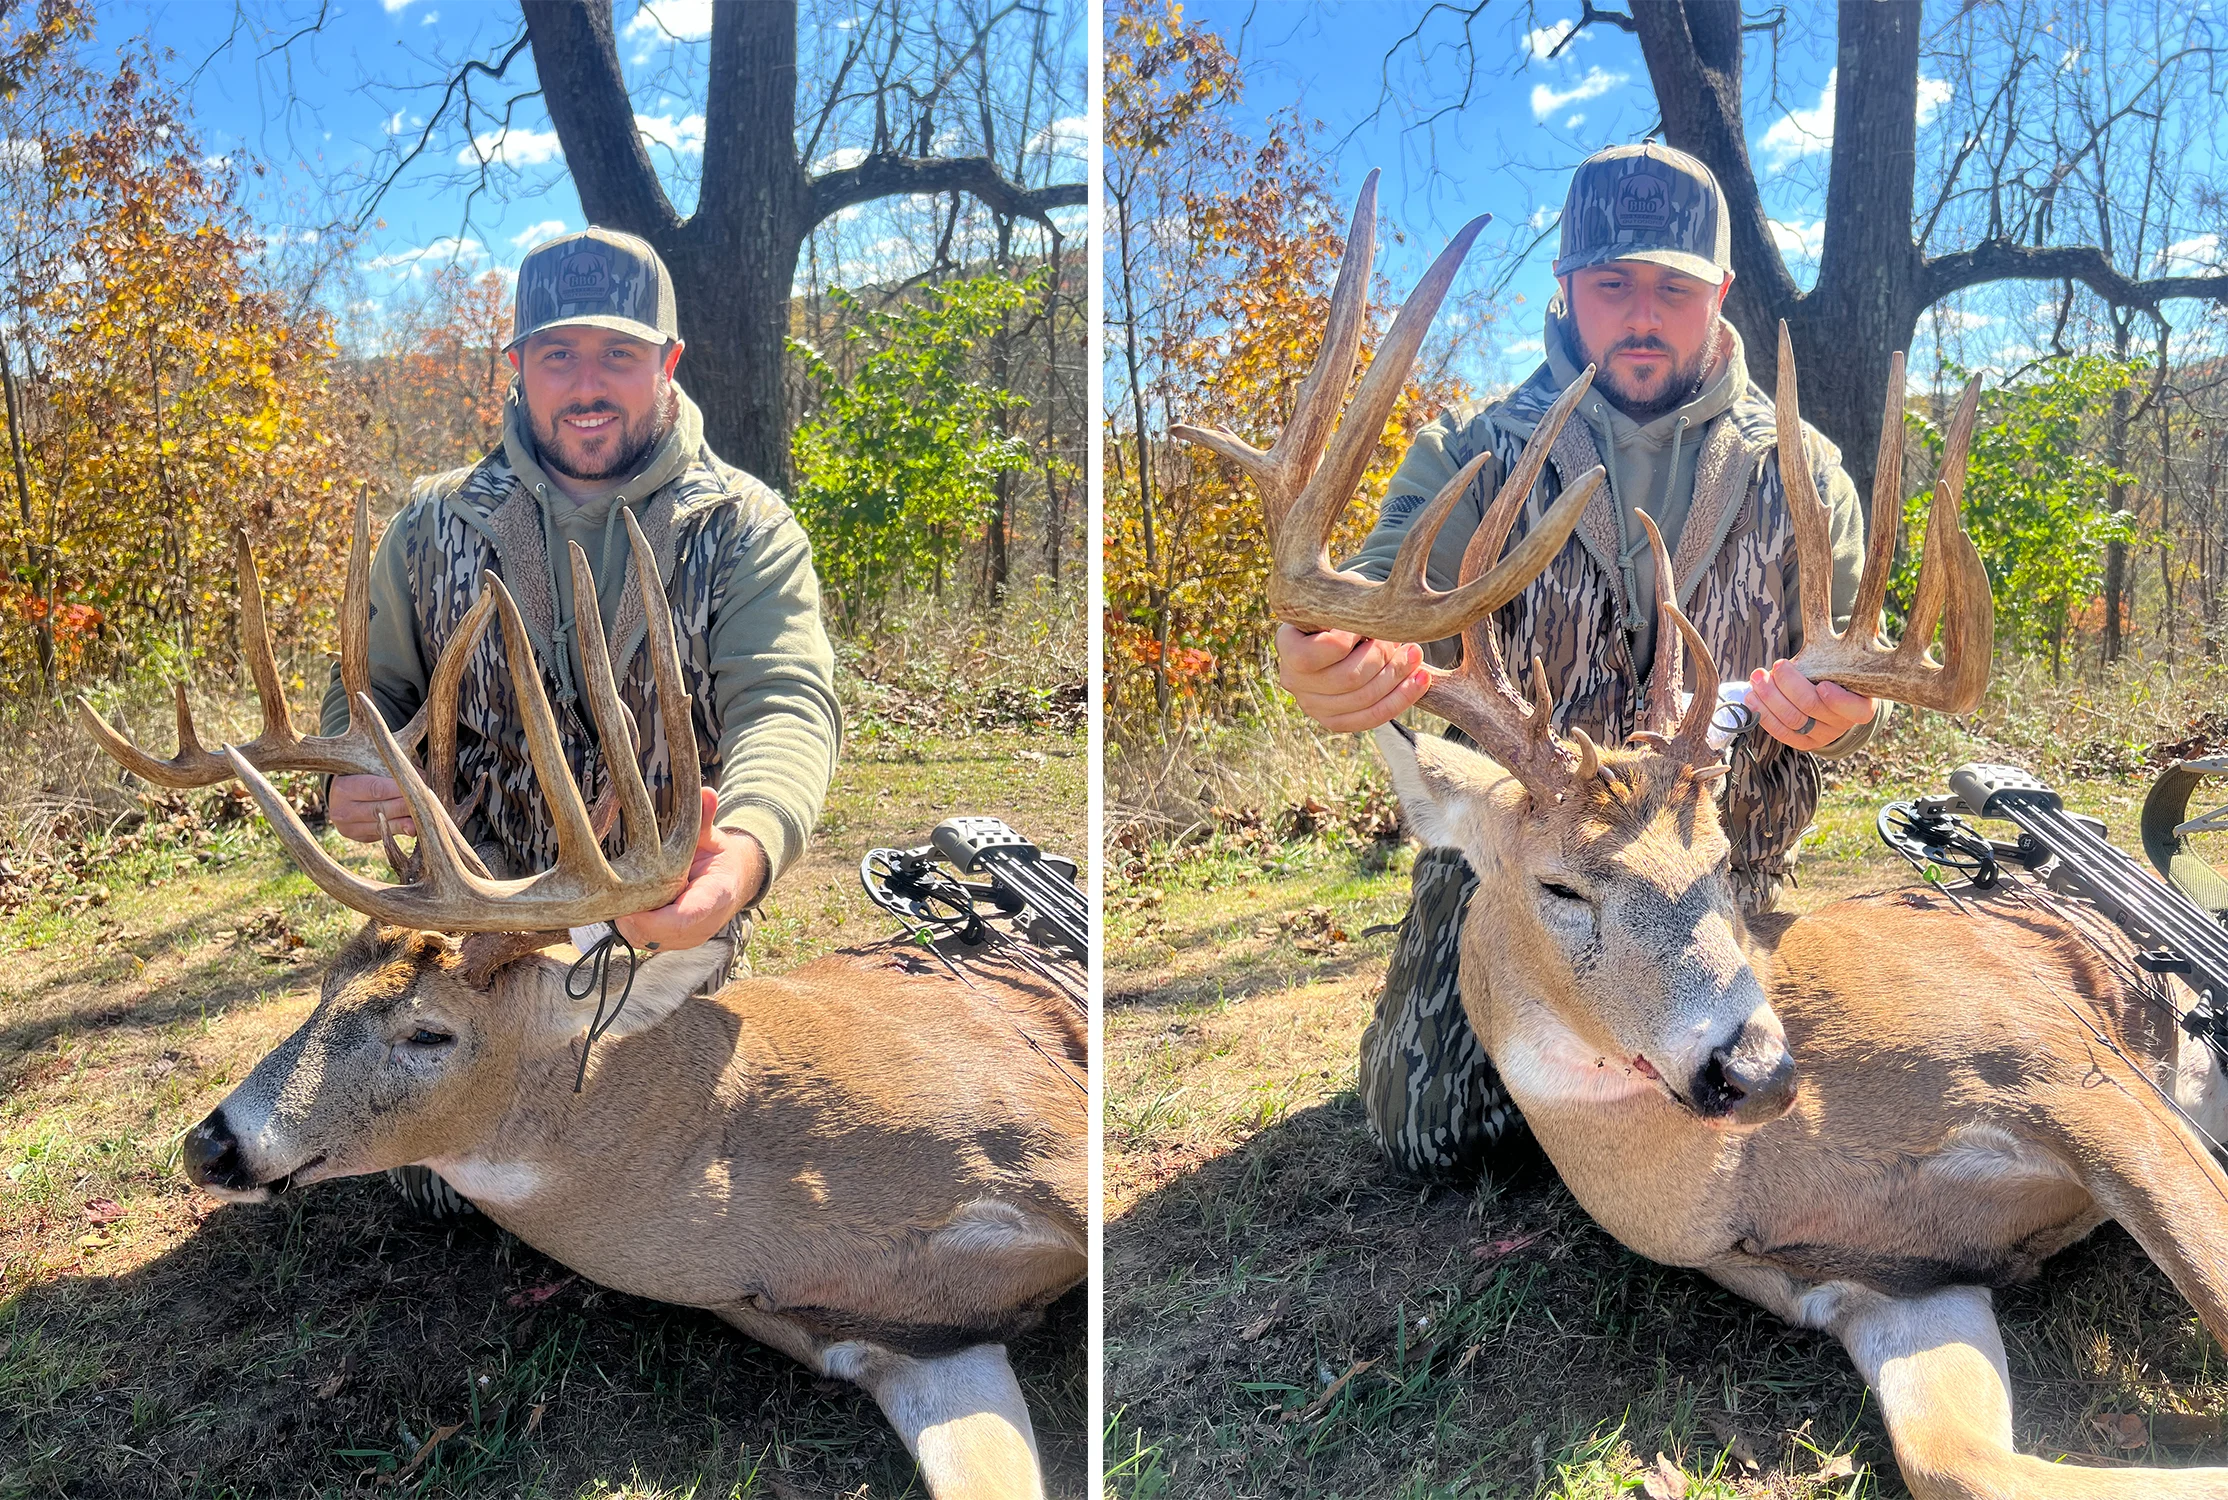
(1176, 176, 2228, 1500)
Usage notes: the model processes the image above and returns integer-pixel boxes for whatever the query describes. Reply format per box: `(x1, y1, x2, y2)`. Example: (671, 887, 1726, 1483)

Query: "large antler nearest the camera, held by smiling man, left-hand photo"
(225, 510, 702, 932)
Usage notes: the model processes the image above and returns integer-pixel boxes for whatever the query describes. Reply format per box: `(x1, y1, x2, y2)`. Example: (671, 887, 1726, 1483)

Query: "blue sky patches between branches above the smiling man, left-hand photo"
(96, 0, 1085, 327)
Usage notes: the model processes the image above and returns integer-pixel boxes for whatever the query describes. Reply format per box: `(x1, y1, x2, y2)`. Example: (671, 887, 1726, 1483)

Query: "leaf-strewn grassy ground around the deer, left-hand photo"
(0, 731, 1092, 1500)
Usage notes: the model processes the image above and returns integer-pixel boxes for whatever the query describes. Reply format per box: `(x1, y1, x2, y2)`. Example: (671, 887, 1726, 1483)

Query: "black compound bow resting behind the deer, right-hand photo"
(1878, 756, 2228, 1065)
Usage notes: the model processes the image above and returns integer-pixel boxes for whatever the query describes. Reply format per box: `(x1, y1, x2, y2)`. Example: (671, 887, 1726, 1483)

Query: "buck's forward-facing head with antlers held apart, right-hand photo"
(1172, 172, 1990, 1128)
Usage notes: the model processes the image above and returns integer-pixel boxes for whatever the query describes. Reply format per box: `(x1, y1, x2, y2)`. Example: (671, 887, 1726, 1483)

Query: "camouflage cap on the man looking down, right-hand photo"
(1555, 140, 1733, 285)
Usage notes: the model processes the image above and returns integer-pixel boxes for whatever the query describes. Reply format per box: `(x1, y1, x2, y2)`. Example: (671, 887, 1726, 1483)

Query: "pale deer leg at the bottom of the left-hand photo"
(824, 1344, 1045, 1500)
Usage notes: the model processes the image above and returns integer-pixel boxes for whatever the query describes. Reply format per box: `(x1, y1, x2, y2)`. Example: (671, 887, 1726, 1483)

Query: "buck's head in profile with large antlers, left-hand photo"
(85, 501, 717, 1201)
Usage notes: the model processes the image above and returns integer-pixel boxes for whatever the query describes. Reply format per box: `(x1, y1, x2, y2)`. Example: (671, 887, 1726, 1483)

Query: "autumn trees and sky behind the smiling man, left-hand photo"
(0, 0, 1087, 842)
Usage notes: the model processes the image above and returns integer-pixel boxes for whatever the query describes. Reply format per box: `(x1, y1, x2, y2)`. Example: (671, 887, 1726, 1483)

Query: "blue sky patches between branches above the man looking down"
(1185, 0, 2221, 386)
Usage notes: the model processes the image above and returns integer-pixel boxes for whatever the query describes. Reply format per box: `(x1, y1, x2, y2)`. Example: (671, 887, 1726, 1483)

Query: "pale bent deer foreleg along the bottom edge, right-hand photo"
(1814, 1286, 2228, 1500)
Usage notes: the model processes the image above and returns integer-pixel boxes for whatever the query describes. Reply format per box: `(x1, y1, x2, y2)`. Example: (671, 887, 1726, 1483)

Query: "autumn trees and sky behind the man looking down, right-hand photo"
(1103, 0, 2228, 793)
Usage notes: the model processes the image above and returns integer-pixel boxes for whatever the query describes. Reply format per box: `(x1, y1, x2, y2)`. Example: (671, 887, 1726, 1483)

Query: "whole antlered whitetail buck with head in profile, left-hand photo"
(85, 506, 1087, 1500)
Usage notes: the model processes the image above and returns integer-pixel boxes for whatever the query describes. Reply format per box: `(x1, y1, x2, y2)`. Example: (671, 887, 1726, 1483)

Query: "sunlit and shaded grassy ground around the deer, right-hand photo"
(1105, 673, 2228, 1500)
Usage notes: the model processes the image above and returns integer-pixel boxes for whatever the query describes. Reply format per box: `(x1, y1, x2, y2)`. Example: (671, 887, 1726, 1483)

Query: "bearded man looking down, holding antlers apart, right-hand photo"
(1277, 143, 1876, 1177)
